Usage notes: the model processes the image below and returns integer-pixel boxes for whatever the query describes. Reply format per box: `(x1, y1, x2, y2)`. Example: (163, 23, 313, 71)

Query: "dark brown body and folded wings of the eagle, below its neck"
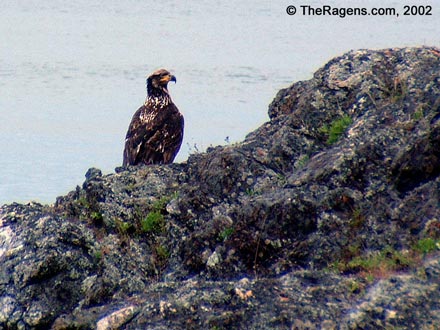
(123, 104, 183, 166)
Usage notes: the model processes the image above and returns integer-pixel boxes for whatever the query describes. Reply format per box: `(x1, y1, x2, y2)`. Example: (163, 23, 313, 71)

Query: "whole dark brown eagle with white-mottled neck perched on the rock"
(122, 69, 184, 166)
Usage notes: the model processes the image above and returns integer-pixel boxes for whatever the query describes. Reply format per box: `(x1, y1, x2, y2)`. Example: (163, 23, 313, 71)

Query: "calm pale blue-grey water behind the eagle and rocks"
(0, 0, 440, 204)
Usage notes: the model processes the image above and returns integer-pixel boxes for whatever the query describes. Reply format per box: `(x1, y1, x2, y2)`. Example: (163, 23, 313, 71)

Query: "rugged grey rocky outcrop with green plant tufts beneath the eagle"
(0, 47, 440, 329)
